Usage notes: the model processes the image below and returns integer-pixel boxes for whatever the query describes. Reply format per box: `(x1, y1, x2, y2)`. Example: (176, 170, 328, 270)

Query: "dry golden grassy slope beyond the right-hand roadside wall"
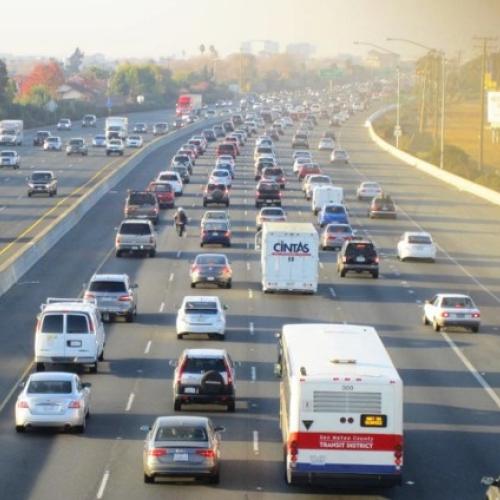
(374, 101, 500, 191)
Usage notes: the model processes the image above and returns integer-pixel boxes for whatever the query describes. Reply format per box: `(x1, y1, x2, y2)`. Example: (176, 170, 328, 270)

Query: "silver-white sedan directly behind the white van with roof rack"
(16, 372, 90, 432)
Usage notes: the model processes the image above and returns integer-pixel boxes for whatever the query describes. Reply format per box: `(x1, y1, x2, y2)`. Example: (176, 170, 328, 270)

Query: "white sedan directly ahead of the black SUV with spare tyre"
(176, 295, 227, 339)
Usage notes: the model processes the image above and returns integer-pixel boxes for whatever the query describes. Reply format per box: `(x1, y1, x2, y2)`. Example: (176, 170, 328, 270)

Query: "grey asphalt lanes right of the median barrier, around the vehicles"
(0, 103, 500, 500)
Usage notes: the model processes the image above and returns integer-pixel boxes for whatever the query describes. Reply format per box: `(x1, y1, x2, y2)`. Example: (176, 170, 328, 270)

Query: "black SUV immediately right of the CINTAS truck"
(337, 238, 379, 278)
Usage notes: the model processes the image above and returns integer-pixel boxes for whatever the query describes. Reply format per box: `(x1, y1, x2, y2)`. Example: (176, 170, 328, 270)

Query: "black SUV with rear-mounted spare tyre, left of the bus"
(173, 349, 236, 412)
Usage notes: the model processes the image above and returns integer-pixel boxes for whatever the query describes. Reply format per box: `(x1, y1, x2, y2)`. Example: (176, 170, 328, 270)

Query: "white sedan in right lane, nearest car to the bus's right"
(422, 293, 481, 333)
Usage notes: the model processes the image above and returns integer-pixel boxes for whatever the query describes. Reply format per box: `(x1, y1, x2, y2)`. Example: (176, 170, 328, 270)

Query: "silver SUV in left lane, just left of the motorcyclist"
(115, 219, 157, 257)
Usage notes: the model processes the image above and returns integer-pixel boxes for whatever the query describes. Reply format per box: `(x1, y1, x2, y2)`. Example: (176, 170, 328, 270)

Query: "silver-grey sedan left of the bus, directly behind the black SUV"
(141, 416, 224, 484)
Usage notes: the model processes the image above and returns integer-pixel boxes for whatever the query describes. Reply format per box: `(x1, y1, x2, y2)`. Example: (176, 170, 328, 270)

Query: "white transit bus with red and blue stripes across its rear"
(275, 324, 403, 486)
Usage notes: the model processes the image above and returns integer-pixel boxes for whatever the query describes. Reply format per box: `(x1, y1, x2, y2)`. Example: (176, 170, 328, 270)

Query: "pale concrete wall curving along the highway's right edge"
(365, 105, 500, 205)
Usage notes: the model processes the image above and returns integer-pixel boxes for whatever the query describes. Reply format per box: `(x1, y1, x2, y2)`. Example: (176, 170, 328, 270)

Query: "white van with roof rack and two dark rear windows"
(35, 297, 106, 373)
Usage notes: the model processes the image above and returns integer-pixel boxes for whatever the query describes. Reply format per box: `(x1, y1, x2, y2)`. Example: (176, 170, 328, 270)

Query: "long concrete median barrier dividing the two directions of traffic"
(0, 119, 217, 297)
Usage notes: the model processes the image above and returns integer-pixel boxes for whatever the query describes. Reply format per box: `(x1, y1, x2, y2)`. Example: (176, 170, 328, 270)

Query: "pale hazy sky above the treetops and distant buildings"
(0, 0, 500, 58)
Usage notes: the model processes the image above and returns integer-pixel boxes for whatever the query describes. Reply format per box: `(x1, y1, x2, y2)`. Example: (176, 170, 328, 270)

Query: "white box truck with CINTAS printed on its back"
(260, 222, 319, 293)
